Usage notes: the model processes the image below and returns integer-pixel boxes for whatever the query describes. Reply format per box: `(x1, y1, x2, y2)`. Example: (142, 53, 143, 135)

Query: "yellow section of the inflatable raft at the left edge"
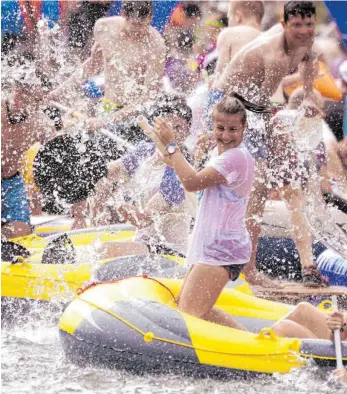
(1, 227, 134, 301)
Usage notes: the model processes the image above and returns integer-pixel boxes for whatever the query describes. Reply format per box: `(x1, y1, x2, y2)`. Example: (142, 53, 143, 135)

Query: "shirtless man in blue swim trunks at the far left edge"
(1, 69, 54, 238)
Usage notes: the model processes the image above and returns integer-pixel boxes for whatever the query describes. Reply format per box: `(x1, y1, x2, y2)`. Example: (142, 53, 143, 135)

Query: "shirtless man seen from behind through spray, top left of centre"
(50, 0, 166, 129)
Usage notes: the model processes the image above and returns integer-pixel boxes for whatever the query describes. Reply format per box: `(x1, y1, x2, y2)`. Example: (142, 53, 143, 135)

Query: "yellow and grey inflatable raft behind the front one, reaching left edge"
(1, 225, 251, 301)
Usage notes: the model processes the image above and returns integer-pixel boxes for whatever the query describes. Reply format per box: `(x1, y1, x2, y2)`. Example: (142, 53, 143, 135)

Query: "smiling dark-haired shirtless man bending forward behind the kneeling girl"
(209, 1, 323, 286)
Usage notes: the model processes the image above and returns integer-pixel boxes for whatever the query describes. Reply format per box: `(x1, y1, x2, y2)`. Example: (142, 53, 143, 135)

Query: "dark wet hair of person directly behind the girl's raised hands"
(149, 94, 193, 127)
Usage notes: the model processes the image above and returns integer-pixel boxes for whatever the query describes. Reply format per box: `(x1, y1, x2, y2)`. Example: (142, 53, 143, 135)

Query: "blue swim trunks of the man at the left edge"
(1, 173, 30, 225)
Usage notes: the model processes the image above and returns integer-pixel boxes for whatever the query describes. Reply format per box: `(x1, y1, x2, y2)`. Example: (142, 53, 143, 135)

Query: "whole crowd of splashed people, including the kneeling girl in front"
(1, 0, 347, 379)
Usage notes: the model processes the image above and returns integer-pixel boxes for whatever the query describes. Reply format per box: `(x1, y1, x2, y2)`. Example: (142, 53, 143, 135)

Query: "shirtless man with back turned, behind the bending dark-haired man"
(215, 1, 264, 78)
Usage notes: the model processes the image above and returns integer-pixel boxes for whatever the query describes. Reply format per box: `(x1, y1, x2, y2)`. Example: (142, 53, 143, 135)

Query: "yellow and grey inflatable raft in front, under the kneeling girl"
(59, 277, 347, 376)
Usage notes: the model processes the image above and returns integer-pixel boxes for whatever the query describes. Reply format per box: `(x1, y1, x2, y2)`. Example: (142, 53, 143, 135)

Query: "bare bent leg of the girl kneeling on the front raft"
(178, 264, 247, 331)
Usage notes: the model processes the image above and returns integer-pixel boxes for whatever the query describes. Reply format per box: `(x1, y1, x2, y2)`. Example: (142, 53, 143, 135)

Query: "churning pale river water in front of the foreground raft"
(1, 306, 346, 394)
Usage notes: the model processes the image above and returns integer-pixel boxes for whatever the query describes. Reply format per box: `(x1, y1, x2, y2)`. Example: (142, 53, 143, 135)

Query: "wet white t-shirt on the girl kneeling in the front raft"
(187, 143, 254, 265)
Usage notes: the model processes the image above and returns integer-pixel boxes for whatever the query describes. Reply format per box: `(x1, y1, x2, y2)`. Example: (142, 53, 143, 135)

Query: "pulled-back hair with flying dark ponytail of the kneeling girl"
(214, 92, 271, 122)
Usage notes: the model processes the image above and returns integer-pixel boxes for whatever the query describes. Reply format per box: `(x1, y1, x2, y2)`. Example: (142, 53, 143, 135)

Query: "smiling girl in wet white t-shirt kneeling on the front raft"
(155, 94, 254, 329)
